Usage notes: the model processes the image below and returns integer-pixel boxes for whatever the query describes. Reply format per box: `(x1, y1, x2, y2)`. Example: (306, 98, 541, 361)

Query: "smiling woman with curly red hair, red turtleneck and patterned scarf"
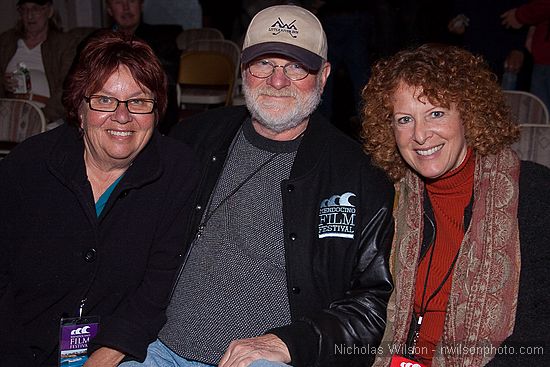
(363, 45, 550, 367)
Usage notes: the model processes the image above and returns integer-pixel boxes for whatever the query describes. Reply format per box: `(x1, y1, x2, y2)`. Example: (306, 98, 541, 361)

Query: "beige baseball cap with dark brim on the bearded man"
(241, 5, 327, 70)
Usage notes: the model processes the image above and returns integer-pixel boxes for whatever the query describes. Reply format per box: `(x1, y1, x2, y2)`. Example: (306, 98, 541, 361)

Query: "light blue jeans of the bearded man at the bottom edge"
(119, 339, 291, 367)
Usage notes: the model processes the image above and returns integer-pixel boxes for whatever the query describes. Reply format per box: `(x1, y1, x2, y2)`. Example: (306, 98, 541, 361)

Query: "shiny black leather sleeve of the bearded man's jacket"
(268, 207, 393, 367)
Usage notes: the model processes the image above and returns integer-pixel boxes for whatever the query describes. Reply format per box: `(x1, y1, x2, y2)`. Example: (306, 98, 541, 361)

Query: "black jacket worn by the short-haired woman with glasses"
(0, 125, 197, 367)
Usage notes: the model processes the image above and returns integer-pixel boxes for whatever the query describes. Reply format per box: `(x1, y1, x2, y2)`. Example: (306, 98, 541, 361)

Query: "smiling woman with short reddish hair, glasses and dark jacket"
(0, 31, 197, 367)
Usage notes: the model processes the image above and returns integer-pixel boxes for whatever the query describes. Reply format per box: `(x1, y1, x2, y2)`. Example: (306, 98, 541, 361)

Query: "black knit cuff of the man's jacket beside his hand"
(266, 321, 321, 367)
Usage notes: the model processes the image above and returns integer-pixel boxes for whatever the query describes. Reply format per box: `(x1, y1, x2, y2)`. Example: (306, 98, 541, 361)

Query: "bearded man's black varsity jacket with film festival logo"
(171, 106, 394, 367)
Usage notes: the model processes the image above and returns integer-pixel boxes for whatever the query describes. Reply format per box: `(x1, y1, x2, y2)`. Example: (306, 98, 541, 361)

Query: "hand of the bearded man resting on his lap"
(219, 334, 290, 367)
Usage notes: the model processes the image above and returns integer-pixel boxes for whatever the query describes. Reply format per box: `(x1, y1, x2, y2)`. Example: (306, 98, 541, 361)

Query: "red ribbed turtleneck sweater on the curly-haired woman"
(414, 149, 475, 366)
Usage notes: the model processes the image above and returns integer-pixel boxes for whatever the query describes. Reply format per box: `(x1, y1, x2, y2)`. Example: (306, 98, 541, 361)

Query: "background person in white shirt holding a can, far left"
(0, 0, 75, 122)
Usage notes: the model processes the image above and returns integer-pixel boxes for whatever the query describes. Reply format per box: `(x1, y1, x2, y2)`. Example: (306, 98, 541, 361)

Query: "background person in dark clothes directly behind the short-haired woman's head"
(107, 0, 182, 133)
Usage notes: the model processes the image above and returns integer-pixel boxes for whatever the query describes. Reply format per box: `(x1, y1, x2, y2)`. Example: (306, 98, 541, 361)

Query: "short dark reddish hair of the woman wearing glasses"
(63, 30, 167, 126)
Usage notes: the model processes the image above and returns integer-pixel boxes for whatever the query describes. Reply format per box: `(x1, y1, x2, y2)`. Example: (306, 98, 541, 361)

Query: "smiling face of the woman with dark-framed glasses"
(80, 65, 156, 168)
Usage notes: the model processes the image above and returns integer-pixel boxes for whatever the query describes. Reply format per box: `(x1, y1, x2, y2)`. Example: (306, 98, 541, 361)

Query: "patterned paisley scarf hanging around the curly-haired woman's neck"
(374, 149, 520, 367)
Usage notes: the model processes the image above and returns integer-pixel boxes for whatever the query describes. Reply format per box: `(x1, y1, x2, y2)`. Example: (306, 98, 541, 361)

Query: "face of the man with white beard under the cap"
(243, 57, 330, 139)
